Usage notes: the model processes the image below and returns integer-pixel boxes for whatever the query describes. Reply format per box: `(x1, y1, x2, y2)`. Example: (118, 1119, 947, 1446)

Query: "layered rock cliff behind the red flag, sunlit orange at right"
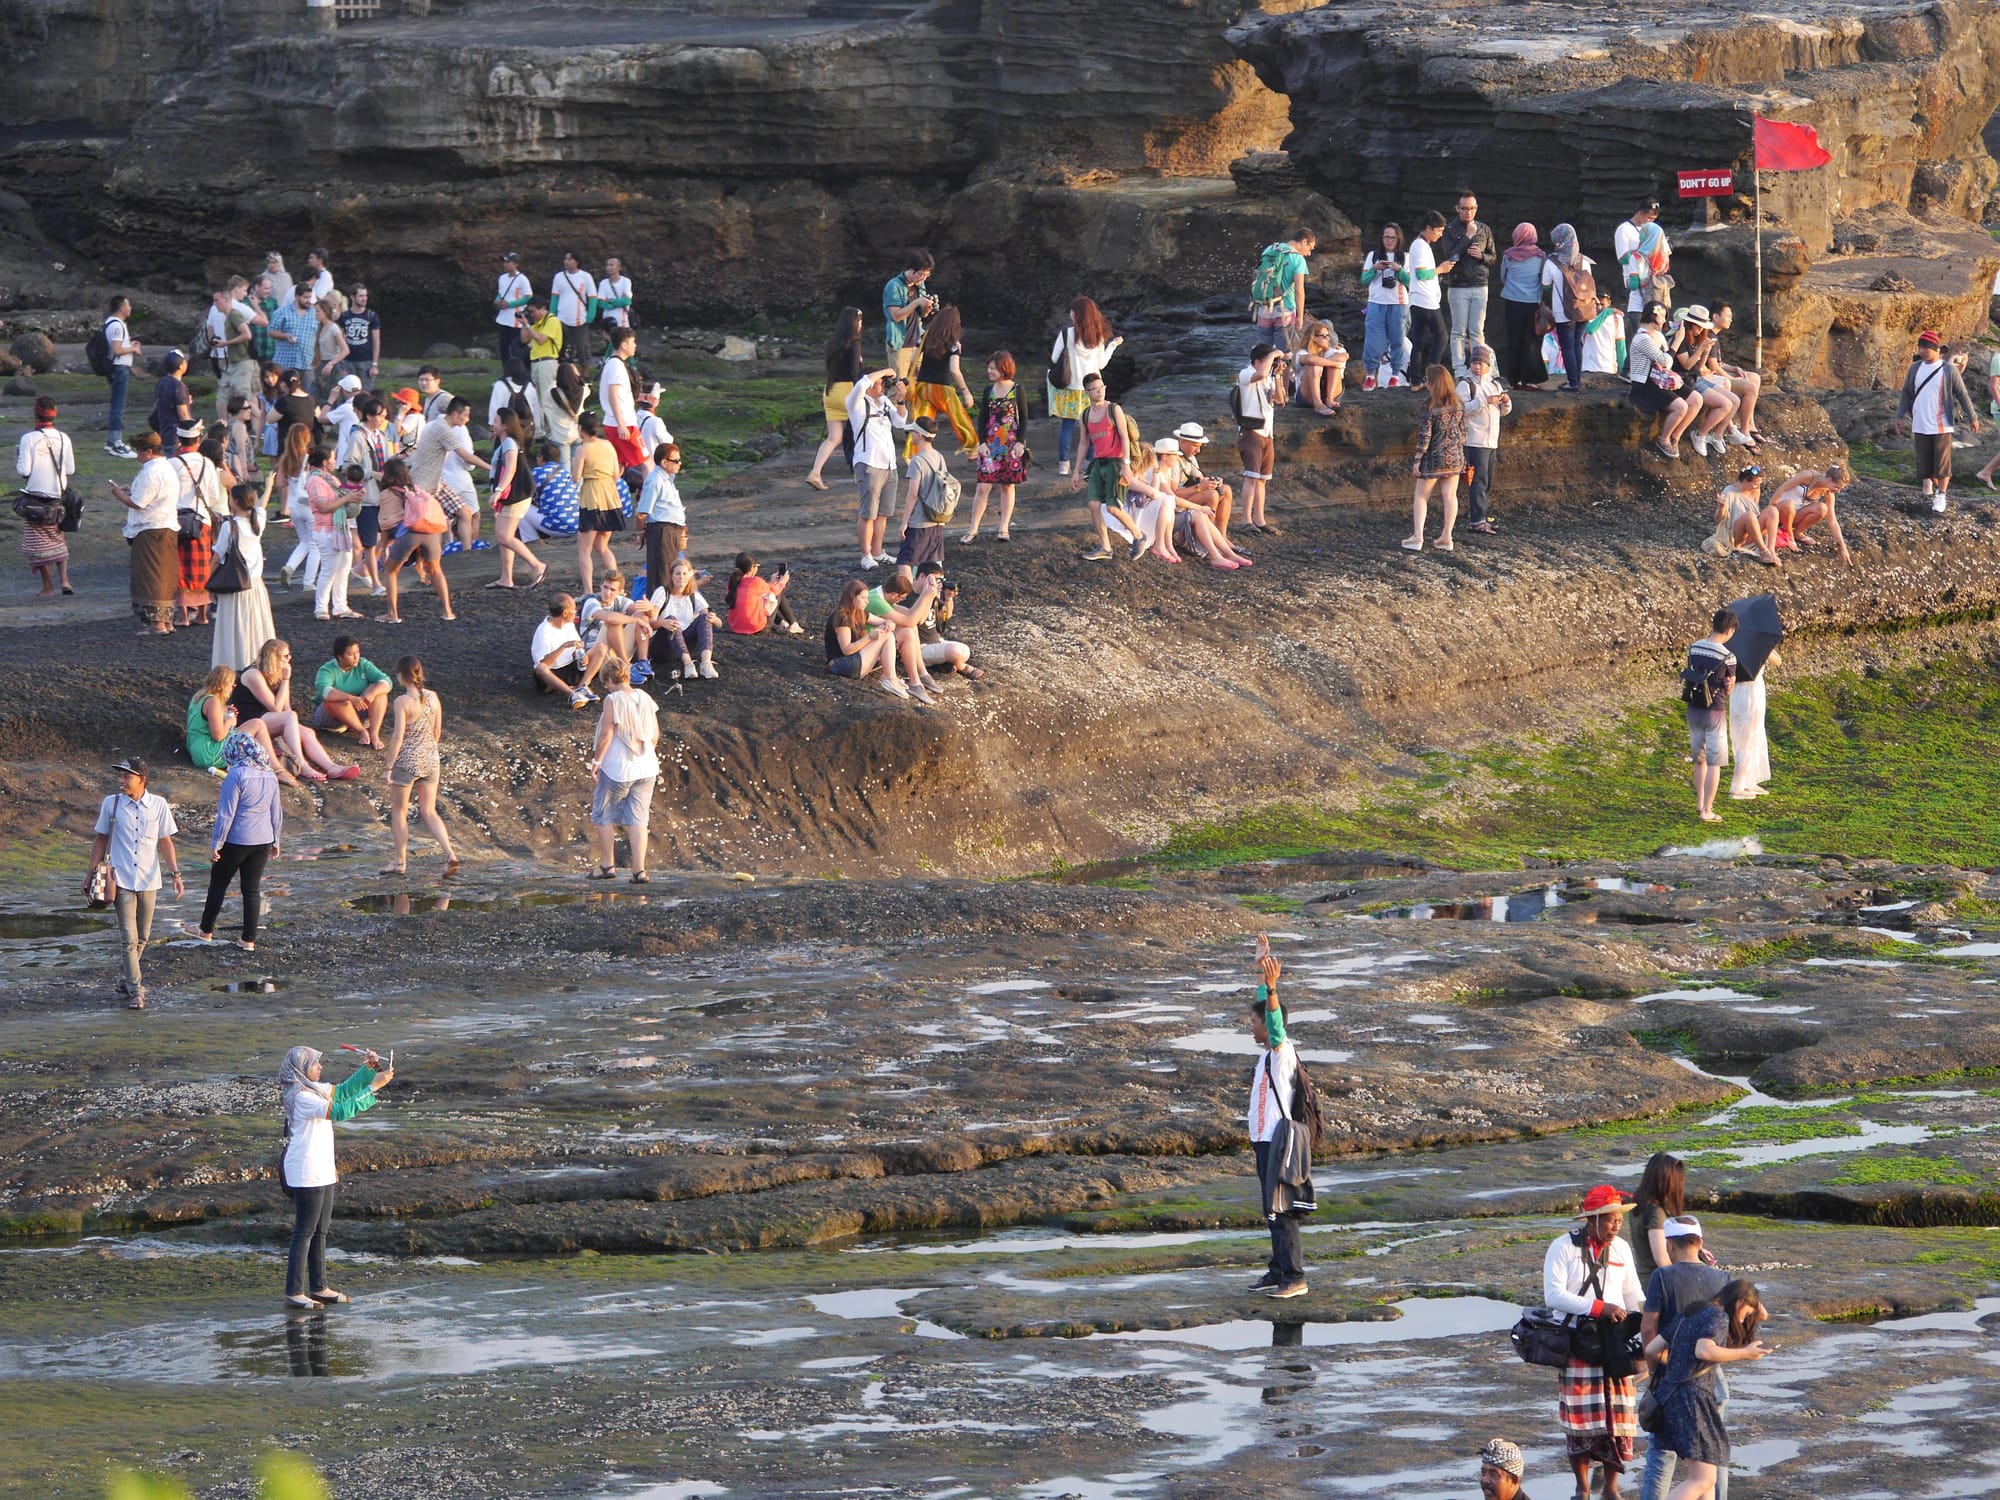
(1230, 0, 2000, 384)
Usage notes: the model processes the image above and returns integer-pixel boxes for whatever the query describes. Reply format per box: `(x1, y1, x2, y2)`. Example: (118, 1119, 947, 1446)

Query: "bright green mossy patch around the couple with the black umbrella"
(1156, 656, 2000, 876)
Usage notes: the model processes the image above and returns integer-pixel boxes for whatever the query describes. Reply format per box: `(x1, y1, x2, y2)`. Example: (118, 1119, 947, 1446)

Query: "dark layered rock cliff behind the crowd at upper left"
(6, 0, 1286, 332)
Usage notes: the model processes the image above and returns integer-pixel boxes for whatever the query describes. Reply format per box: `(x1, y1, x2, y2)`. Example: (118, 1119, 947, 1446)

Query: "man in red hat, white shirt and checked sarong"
(1542, 1184, 1646, 1500)
